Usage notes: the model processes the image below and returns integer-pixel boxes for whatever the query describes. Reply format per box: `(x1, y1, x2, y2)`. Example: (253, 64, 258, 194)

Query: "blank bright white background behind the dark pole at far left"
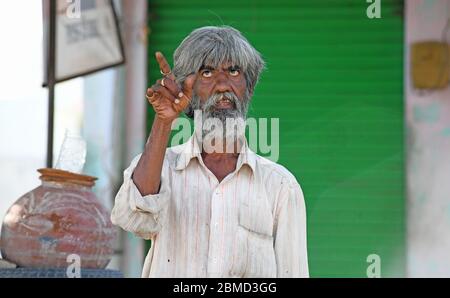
(0, 0, 83, 247)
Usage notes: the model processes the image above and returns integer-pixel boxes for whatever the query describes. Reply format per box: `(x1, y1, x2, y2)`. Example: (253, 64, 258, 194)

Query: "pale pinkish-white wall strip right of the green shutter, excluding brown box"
(405, 0, 450, 277)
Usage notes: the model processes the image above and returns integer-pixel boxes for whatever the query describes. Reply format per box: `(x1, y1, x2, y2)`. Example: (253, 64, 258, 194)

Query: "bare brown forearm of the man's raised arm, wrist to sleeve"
(133, 117, 171, 196)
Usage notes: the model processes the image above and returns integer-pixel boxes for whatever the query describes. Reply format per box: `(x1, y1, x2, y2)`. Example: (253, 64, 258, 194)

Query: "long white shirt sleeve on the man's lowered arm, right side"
(274, 177, 309, 277)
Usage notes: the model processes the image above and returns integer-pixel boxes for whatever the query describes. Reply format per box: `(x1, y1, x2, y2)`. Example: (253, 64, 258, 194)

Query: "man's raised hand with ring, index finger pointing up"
(147, 52, 196, 124)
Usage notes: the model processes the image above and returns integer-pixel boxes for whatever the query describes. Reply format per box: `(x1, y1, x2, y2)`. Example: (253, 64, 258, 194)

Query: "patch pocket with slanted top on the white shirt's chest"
(230, 224, 277, 278)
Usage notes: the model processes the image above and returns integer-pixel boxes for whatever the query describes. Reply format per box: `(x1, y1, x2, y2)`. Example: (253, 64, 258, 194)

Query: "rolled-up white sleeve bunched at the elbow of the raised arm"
(111, 155, 170, 239)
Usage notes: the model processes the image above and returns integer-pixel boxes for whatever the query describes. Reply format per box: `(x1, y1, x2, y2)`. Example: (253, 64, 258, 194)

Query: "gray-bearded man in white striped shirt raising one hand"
(111, 27, 309, 277)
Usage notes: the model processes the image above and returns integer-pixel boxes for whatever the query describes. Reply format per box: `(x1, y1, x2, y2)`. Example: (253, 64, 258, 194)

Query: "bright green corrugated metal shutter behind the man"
(148, 0, 405, 277)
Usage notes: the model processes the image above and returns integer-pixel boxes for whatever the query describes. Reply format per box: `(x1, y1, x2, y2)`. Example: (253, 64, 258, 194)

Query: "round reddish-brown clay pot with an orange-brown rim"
(1, 169, 115, 268)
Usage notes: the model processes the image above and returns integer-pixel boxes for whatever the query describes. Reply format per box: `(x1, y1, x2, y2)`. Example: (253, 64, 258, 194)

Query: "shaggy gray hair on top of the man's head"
(173, 26, 265, 95)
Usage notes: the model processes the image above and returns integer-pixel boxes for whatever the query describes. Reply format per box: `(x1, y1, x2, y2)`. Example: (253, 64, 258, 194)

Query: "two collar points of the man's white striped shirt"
(175, 132, 256, 172)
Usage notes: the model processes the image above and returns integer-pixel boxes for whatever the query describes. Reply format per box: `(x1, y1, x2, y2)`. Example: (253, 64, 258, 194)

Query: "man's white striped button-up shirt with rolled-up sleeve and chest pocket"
(111, 137, 309, 277)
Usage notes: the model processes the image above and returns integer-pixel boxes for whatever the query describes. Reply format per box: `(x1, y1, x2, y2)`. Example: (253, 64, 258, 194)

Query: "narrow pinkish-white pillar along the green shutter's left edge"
(115, 0, 147, 277)
